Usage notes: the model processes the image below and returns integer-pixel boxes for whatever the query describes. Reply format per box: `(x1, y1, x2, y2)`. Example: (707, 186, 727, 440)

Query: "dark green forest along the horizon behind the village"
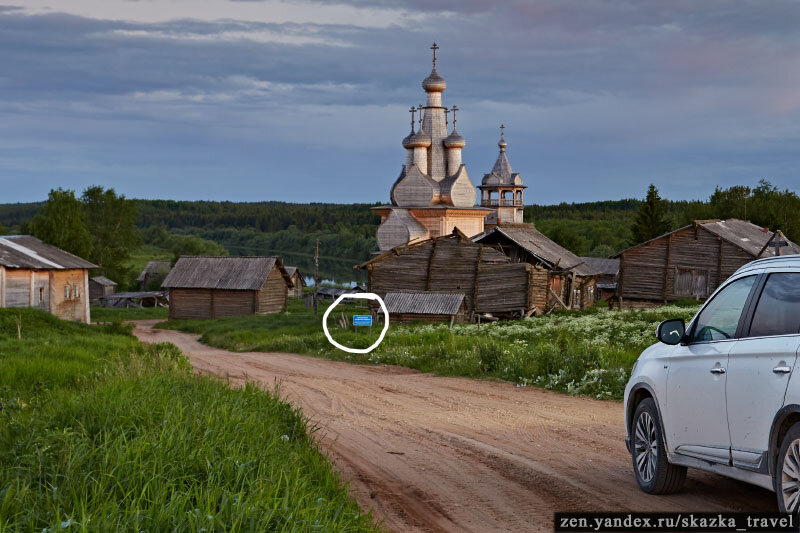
(0, 180, 800, 282)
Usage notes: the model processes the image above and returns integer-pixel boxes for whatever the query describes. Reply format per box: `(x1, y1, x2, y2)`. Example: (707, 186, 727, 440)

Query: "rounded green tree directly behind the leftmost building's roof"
(28, 188, 92, 258)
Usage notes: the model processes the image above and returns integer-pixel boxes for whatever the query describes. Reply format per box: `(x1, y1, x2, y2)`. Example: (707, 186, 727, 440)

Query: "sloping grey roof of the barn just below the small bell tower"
(473, 224, 595, 276)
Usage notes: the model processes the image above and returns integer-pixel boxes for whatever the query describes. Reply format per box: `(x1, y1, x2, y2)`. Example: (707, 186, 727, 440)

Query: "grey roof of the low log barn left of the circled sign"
(161, 256, 292, 291)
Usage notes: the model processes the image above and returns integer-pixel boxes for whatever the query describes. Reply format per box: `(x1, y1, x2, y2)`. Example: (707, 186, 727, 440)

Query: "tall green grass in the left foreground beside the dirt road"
(0, 309, 375, 532)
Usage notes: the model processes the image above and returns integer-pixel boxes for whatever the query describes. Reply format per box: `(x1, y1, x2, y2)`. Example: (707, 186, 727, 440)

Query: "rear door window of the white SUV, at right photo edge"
(749, 272, 800, 337)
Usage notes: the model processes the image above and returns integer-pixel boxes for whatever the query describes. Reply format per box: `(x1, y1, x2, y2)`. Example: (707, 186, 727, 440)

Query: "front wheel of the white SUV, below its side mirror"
(631, 398, 686, 494)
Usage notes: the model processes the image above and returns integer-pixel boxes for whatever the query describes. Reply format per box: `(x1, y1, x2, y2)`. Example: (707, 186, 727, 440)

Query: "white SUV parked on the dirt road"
(624, 255, 800, 512)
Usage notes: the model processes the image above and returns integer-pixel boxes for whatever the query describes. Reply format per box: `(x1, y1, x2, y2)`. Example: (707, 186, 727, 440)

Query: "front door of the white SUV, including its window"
(664, 275, 757, 462)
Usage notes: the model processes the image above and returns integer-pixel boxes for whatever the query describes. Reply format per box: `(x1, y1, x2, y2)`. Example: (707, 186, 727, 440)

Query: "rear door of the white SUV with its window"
(726, 272, 800, 469)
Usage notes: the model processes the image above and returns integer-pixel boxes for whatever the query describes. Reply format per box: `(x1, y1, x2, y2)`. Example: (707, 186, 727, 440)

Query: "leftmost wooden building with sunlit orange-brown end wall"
(0, 235, 97, 323)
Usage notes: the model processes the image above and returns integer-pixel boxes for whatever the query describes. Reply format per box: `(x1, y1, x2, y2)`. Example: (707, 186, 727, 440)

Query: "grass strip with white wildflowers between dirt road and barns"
(157, 301, 697, 399)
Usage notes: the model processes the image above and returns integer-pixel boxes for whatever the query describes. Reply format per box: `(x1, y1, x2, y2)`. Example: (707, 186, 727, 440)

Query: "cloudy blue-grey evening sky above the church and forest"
(0, 0, 800, 204)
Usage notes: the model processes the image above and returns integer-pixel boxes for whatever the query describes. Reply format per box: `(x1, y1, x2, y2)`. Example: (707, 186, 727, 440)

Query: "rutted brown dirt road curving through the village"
(135, 321, 775, 532)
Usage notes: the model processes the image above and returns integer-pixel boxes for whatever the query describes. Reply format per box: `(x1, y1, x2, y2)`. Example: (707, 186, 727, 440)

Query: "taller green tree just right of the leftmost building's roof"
(81, 185, 142, 280)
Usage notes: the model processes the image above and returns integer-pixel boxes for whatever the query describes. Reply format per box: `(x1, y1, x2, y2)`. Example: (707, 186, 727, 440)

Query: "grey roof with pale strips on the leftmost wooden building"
(0, 235, 97, 270)
